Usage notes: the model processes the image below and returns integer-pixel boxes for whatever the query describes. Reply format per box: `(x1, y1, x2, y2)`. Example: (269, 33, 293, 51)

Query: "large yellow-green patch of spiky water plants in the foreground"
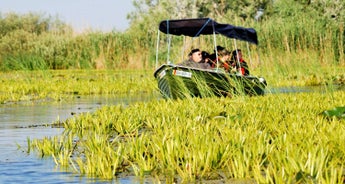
(30, 92, 345, 183)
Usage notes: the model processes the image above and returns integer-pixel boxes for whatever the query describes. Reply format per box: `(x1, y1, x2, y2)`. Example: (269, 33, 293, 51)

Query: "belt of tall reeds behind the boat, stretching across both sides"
(0, 11, 345, 74)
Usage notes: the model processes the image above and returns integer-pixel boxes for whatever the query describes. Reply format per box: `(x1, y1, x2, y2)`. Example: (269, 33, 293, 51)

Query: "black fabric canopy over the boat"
(159, 18, 258, 44)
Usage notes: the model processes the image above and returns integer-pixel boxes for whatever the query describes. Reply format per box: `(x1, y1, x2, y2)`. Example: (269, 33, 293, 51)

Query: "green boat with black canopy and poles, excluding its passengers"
(154, 18, 267, 99)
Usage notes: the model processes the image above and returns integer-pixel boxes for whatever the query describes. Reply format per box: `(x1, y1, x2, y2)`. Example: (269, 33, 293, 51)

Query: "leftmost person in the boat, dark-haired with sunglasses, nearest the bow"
(177, 49, 212, 69)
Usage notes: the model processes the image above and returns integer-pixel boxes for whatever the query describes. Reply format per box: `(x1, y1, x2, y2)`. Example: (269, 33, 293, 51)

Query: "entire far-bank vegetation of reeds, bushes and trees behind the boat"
(0, 0, 345, 71)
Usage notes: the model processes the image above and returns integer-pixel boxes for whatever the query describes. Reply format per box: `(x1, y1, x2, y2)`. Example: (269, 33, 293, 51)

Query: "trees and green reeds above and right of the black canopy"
(129, 0, 345, 64)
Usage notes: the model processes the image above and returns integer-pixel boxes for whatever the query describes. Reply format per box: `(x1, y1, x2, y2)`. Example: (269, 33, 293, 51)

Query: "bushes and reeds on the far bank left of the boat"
(0, 13, 148, 71)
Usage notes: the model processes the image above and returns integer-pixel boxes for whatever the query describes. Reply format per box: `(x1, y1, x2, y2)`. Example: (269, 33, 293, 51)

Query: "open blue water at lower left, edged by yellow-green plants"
(0, 95, 156, 183)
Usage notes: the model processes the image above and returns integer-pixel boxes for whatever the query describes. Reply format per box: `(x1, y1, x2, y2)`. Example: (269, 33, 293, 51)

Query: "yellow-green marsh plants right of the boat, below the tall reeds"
(250, 49, 344, 86)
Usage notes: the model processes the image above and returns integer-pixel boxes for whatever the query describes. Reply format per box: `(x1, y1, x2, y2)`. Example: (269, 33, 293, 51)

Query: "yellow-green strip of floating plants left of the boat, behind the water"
(0, 70, 157, 103)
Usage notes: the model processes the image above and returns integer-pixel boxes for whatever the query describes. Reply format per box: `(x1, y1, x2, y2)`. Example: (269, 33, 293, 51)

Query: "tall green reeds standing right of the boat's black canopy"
(256, 13, 345, 66)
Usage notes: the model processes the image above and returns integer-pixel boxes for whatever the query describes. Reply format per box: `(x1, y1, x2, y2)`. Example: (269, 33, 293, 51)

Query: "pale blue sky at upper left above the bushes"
(0, 0, 134, 32)
